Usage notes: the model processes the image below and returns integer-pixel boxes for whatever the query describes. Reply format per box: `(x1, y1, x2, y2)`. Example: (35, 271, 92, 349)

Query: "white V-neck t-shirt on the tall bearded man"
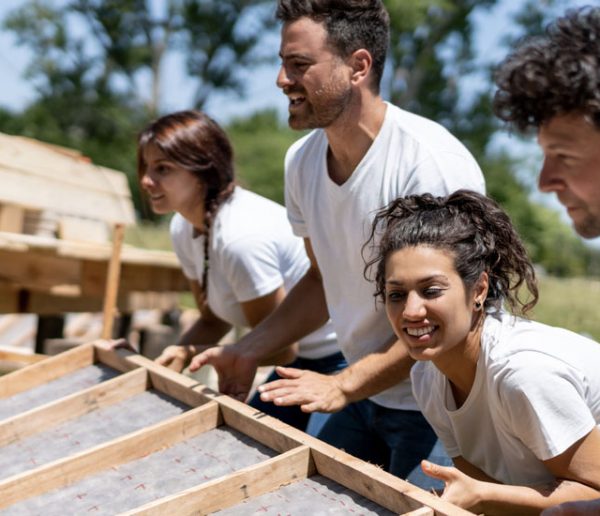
(285, 104, 485, 410)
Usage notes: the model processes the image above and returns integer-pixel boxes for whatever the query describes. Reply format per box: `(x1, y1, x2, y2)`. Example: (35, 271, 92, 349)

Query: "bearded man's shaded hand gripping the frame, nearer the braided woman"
(189, 344, 258, 401)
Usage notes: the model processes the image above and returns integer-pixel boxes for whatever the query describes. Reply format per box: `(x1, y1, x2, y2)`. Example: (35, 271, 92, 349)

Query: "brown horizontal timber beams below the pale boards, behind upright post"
(0, 232, 188, 314)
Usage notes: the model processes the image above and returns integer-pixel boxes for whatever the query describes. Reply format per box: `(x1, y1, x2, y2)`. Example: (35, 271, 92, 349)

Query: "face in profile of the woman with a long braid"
(140, 143, 204, 223)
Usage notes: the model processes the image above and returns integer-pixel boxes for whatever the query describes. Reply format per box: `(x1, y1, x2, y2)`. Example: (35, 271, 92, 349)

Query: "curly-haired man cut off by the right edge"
(494, 7, 600, 516)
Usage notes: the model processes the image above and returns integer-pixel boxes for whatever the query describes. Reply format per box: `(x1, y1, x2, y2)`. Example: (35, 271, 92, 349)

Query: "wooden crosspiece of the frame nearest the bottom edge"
(122, 446, 314, 516)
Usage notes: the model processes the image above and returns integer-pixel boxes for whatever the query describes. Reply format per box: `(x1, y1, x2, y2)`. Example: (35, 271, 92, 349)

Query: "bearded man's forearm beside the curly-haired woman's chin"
(336, 337, 414, 402)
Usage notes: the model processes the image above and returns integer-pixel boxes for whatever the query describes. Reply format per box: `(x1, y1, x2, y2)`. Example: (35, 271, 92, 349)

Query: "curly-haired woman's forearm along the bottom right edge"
(476, 480, 600, 516)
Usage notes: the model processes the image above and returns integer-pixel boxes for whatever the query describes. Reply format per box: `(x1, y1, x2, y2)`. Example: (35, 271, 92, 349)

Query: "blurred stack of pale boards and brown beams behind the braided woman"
(0, 133, 188, 314)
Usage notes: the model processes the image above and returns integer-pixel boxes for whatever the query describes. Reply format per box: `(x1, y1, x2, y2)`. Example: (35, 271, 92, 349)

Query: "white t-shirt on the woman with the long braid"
(171, 186, 339, 358)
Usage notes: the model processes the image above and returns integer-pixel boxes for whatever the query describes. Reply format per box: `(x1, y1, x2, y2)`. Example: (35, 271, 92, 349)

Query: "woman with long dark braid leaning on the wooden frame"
(138, 111, 345, 430)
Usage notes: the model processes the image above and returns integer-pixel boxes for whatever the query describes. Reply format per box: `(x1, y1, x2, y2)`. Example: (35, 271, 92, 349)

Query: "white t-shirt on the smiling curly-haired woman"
(411, 314, 600, 485)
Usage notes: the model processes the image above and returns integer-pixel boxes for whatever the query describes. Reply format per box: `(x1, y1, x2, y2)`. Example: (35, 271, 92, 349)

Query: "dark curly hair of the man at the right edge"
(494, 7, 600, 131)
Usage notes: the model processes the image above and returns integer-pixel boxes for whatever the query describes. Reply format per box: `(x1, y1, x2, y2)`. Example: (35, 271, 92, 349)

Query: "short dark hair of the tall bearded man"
(277, 0, 390, 93)
